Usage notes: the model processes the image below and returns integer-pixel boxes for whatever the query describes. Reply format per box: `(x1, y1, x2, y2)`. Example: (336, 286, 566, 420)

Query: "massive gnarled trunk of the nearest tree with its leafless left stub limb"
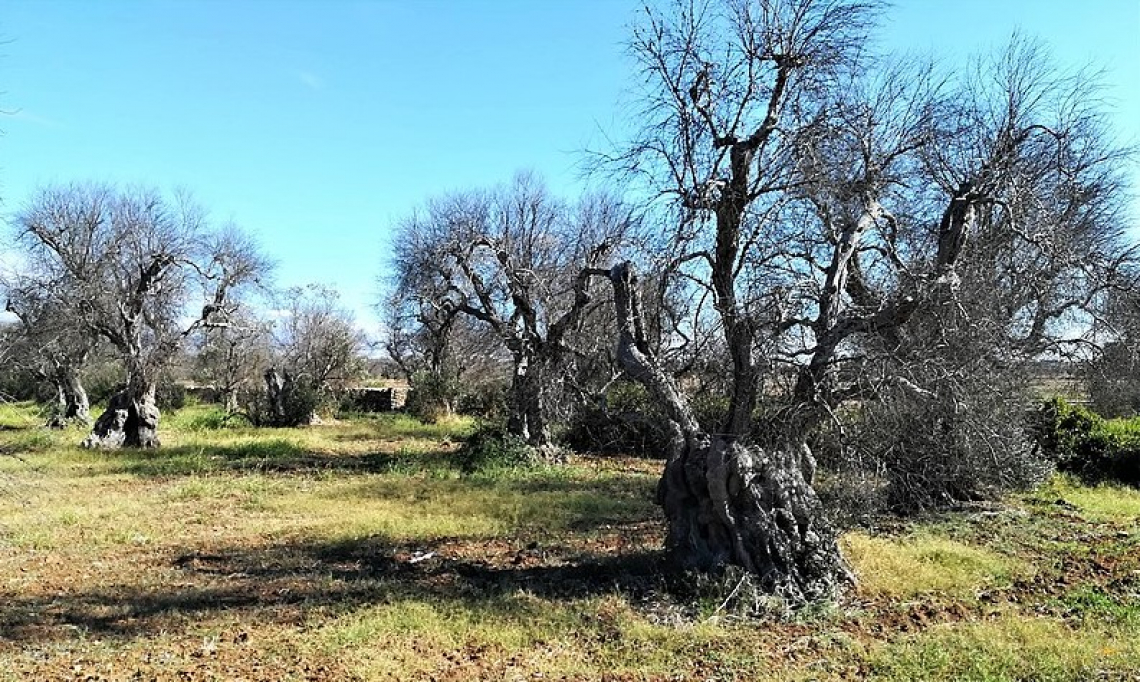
(608, 263, 854, 603)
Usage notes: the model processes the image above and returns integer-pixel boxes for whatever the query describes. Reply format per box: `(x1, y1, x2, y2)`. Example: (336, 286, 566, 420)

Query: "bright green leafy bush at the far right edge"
(1032, 398, 1140, 486)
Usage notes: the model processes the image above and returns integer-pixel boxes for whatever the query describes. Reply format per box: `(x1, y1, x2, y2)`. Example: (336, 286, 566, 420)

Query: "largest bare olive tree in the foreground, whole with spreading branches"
(599, 0, 1127, 601)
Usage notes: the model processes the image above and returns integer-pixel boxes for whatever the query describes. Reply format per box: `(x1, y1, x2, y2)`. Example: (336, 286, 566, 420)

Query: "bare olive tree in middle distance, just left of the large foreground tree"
(394, 174, 632, 447)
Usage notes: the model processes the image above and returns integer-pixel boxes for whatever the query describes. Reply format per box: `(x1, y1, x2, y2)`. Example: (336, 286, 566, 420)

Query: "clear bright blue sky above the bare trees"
(0, 0, 1140, 339)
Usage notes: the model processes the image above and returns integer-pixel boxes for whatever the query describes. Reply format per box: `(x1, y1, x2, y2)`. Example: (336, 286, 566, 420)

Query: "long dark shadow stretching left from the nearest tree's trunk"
(0, 537, 668, 644)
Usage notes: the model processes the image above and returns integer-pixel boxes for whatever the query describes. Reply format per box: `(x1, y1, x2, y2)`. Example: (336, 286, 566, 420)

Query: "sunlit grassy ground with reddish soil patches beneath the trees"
(0, 405, 1140, 681)
